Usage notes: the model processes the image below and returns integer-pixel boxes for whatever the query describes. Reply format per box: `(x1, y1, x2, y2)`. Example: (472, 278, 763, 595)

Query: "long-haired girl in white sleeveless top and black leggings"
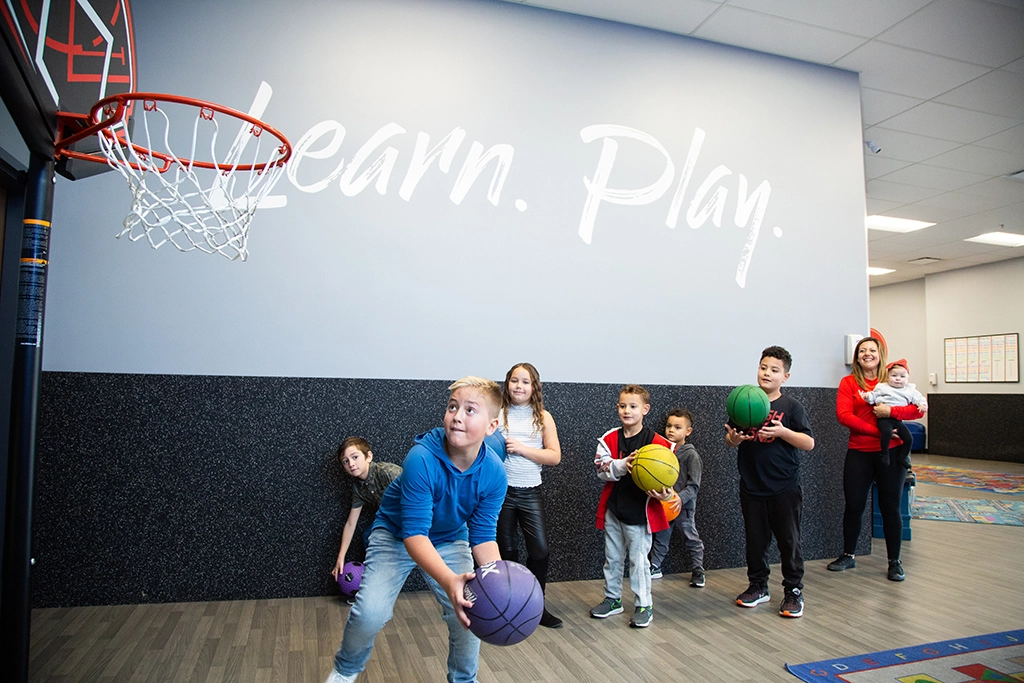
(498, 362, 562, 629)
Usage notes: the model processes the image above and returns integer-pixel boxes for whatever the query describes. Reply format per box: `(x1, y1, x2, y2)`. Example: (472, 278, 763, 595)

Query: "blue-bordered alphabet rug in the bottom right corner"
(785, 631, 1024, 683)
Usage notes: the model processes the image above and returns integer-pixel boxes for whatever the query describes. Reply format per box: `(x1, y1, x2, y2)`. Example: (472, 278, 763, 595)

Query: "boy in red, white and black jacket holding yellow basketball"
(590, 384, 672, 629)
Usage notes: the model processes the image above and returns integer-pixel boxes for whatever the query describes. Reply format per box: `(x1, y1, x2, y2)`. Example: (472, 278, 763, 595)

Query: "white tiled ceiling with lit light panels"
(497, 0, 1024, 287)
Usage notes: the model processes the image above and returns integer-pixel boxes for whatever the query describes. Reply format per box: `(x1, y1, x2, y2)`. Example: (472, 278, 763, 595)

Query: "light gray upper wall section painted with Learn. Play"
(44, 0, 867, 386)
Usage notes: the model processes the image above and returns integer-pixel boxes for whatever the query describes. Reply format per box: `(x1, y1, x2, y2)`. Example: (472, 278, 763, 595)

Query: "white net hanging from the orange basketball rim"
(98, 100, 285, 261)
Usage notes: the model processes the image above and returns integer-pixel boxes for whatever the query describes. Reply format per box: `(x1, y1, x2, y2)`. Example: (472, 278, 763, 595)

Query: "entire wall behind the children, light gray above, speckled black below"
(36, 0, 868, 605)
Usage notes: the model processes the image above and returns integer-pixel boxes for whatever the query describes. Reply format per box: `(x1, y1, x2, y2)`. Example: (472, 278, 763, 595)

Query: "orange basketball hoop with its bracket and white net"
(56, 89, 292, 261)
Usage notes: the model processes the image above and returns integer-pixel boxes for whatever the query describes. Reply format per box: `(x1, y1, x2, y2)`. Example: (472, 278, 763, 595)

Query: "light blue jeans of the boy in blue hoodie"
(334, 528, 480, 683)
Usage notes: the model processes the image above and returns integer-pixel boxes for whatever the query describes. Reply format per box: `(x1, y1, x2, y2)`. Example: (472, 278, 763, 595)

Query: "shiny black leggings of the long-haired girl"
(498, 486, 548, 590)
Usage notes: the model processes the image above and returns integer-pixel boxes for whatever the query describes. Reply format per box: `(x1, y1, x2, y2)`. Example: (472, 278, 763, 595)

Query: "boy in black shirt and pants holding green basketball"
(725, 346, 814, 617)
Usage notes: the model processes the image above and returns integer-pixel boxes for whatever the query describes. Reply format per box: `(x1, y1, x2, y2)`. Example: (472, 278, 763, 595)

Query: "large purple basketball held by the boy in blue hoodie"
(465, 560, 544, 645)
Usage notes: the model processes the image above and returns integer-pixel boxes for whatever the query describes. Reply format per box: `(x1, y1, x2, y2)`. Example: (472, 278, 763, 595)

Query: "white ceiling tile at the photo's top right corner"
(878, 0, 1024, 68)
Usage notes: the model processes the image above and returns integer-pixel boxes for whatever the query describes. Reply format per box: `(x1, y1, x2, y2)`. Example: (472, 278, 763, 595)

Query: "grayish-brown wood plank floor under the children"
(31, 456, 1024, 683)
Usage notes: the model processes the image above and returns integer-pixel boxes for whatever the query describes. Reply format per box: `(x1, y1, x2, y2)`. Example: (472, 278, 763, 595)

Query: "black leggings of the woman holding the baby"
(843, 449, 906, 560)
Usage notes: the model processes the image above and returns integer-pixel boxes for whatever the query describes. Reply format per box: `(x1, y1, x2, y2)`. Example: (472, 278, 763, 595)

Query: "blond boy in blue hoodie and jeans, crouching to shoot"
(327, 377, 508, 683)
